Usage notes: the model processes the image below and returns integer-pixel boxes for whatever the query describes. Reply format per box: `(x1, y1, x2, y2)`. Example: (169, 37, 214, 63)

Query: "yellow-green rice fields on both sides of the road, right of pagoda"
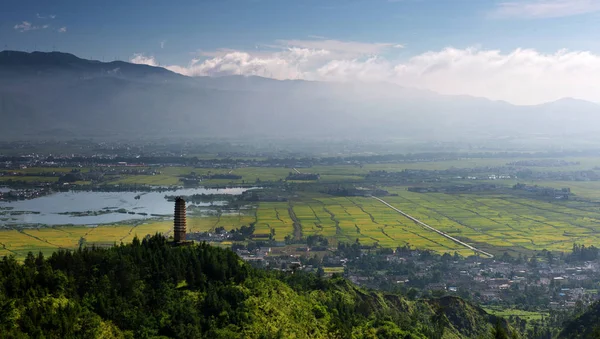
(252, 187, 600, 255)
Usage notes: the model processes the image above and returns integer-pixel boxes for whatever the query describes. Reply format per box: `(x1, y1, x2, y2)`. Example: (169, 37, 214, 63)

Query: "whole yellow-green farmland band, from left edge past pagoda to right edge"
(5, 187, 600, 256)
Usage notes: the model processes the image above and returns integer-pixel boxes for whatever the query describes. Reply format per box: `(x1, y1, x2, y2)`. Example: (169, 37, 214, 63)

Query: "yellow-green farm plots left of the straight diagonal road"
(255, 197, 473, 255)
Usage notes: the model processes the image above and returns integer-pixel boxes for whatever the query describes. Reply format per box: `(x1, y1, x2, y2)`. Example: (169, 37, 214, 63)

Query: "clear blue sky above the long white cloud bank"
(0, 0, 600, 63)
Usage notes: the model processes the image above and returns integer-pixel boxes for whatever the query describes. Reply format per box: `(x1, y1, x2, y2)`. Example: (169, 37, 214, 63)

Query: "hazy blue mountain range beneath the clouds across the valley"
(0, 51, 600, 140)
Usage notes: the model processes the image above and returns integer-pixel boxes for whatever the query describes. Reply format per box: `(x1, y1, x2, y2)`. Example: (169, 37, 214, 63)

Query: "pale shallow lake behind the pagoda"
(0, 187, 252, 225)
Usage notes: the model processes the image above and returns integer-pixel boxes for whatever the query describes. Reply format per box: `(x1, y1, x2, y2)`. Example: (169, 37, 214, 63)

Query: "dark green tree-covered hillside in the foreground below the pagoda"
(0, 235, 511, 338)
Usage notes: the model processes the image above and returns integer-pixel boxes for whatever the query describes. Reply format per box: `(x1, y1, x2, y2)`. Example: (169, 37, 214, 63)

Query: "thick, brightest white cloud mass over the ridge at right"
(393, 48, 600, 104)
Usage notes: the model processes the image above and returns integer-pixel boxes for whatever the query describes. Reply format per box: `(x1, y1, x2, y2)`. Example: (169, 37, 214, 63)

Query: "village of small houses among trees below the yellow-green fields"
(216, 233, 600, 310)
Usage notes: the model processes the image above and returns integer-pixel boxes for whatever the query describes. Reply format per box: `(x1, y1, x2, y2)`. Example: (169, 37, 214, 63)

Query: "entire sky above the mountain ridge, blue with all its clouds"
(0, 0, 600, 104)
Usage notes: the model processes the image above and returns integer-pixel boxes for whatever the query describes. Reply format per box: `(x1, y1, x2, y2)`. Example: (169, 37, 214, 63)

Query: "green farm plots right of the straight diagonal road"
(385, 191, 600, 255)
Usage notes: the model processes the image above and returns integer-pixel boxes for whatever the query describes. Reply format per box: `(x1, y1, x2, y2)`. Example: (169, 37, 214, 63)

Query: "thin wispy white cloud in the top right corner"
(492, 0, 600, 19)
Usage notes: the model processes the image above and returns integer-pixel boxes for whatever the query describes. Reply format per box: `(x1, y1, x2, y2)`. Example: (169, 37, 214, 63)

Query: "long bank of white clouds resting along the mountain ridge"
(131, 38, 600, 104)
